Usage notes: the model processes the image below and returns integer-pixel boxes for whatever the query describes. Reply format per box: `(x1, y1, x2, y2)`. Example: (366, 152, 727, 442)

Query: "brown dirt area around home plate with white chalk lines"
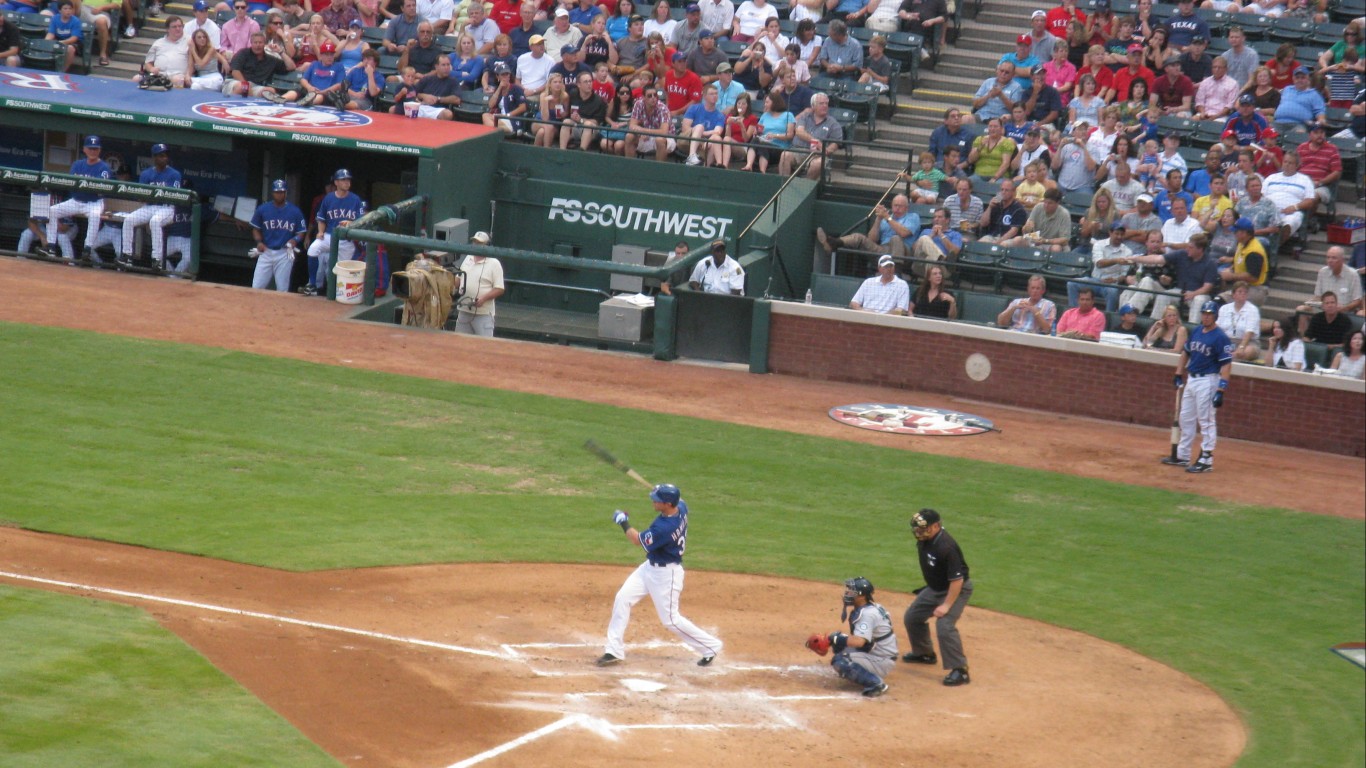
(0, 529, 1244, 768)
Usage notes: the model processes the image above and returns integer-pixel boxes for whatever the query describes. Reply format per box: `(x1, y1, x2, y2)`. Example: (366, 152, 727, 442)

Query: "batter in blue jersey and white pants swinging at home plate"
(597, 482, 721, 667)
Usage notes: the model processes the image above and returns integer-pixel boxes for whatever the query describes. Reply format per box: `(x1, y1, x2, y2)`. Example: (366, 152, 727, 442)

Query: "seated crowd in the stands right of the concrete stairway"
(818, 0, 1366, 374)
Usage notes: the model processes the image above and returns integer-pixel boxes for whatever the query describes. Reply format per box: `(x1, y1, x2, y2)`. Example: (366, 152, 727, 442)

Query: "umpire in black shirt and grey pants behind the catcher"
(902, 508, 973, 686)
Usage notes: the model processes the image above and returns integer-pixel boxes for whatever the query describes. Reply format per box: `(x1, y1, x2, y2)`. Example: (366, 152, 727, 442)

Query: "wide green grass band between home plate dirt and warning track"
(0, 324, 1366, 768)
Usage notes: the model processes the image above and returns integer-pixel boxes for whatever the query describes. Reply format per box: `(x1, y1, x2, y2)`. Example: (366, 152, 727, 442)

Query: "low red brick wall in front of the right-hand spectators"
(768, 302, 1366, 456)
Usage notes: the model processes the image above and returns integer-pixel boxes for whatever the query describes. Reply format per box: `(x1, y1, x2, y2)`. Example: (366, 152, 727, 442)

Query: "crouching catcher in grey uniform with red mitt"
(806, 577, 896, 698)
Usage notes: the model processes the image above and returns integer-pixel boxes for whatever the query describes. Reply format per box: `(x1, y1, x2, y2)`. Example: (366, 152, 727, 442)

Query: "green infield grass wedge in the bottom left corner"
(0, 586, 336, 768)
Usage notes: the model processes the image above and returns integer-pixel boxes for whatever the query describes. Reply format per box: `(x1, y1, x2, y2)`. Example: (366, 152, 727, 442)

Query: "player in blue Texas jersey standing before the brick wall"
(1162, 302, 1233, 473)
